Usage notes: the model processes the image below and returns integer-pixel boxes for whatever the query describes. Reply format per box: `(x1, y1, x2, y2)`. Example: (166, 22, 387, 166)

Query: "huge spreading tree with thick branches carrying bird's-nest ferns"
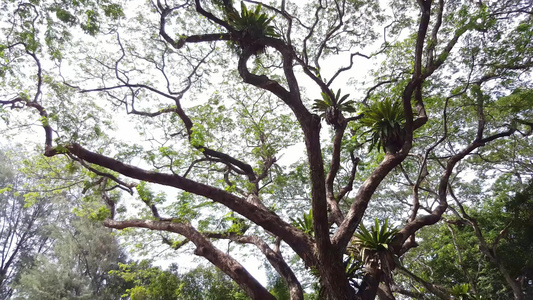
(0, 0, 533, 299)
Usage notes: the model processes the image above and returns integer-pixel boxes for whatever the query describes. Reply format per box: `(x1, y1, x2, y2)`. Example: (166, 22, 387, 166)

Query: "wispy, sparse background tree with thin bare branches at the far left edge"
(0, 148, 58, 299)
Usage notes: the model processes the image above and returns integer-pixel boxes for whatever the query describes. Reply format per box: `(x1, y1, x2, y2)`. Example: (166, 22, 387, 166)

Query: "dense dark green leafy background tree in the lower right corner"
(403, 176, 533, 299)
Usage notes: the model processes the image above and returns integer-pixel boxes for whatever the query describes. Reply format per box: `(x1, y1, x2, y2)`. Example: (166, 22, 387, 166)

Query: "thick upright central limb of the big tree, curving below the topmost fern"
(232, 22, 351, 299)
